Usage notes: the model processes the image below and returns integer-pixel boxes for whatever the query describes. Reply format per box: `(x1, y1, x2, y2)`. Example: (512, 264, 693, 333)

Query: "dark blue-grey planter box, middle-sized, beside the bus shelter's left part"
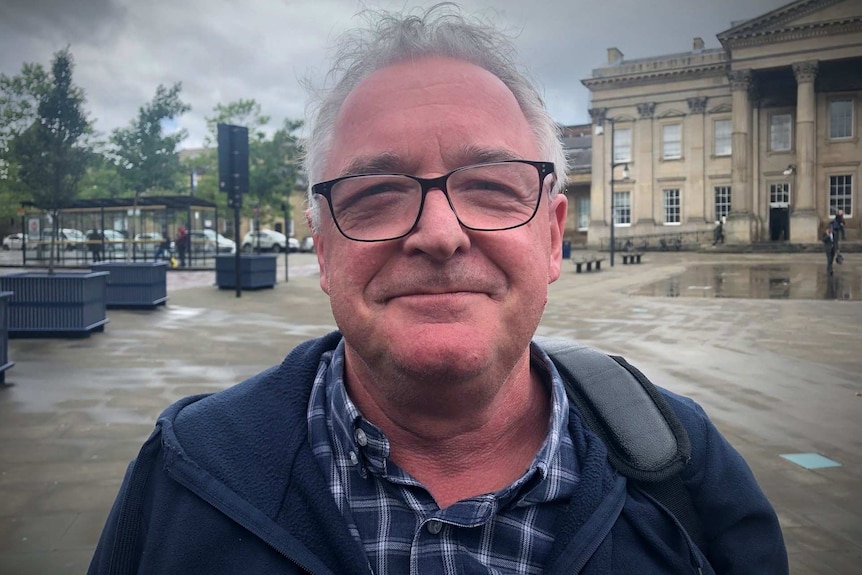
(90, 262, 168, 308)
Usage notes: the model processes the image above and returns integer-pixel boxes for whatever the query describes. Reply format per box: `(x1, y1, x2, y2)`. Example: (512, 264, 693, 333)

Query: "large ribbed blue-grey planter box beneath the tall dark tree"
(0, 271, 109, 338)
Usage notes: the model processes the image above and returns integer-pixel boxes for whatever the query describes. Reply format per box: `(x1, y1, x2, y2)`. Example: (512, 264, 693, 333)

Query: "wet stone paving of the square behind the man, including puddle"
(0, 253, 862, 575)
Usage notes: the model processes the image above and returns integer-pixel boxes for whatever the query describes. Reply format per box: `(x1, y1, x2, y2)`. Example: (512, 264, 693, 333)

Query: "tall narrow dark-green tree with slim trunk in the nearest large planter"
(12, 48, 91, 273)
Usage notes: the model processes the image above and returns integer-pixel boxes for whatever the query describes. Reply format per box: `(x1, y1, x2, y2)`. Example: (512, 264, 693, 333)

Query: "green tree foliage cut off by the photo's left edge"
(0, 64, 51, 232)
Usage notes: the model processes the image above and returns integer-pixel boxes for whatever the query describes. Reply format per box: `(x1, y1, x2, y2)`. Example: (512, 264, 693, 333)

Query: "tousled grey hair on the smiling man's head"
(305, 3, 566, 230)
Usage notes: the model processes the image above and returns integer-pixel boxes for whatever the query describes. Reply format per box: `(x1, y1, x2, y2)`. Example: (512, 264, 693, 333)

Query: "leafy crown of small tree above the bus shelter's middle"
(109, 82, 191, 198)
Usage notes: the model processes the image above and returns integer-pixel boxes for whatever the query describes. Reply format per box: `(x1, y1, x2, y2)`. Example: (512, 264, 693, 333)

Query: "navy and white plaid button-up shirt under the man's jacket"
(308, 340, 578, 575)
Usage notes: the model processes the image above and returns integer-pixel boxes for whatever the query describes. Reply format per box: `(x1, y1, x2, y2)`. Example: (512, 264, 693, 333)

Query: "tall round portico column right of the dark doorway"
(790, 61, 819, 244)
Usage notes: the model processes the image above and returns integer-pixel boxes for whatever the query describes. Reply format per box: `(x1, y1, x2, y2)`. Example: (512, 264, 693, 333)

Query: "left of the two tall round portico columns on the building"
(724, 70, 755, 244)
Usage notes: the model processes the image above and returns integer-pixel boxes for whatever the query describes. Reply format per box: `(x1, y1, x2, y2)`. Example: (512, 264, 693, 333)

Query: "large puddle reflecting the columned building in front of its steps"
(634, 263, 862, 300)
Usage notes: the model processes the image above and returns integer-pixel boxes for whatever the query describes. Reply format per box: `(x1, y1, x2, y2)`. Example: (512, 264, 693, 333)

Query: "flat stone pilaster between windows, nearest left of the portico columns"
(682, 97, 712, 224)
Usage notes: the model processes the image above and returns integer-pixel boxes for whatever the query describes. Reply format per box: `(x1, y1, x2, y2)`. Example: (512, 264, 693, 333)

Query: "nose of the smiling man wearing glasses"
(404, 189, 470, 261)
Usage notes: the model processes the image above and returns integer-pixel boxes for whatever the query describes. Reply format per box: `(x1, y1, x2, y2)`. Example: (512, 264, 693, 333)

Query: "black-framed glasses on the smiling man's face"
(311, 160, 554, 242)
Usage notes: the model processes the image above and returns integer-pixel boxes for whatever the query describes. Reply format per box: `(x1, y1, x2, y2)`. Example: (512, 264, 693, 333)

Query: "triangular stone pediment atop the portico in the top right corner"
(718, 0, 862, 50)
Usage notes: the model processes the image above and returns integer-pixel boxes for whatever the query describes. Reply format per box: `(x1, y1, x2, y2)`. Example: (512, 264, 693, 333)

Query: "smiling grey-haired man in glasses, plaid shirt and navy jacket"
(91, 6, 787, 574)
